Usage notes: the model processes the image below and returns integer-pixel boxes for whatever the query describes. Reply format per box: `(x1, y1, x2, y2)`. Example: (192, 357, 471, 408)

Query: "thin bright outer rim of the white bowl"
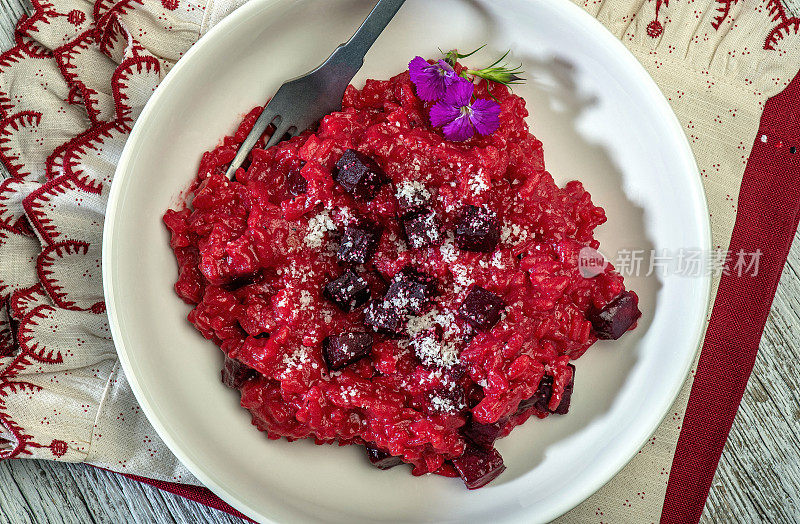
(102, 0, 712, 524)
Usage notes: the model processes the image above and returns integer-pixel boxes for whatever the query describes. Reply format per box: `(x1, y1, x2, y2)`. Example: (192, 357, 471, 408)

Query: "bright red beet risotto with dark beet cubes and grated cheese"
(164, 61, 640, 489)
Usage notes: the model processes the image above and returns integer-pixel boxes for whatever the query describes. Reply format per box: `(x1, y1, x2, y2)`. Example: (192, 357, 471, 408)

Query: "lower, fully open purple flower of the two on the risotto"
(431, 78, 500, 142)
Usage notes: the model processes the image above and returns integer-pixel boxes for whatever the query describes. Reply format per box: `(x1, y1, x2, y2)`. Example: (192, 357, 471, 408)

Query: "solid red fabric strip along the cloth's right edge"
(661, 70, 800, 524)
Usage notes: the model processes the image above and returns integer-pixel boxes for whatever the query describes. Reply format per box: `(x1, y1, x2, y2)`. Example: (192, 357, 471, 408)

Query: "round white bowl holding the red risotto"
(103, 0, 710, 522)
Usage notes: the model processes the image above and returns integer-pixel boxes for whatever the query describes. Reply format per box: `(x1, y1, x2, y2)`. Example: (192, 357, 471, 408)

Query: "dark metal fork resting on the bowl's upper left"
(225, 0, 405, 180)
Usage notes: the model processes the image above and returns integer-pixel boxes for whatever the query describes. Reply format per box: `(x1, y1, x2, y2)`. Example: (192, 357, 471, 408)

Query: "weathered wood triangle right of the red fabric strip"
(704, 229, 800, 523)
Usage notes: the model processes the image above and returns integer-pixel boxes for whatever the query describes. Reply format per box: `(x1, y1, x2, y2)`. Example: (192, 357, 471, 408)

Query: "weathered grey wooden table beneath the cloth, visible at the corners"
(0, 0, 800, 524)
